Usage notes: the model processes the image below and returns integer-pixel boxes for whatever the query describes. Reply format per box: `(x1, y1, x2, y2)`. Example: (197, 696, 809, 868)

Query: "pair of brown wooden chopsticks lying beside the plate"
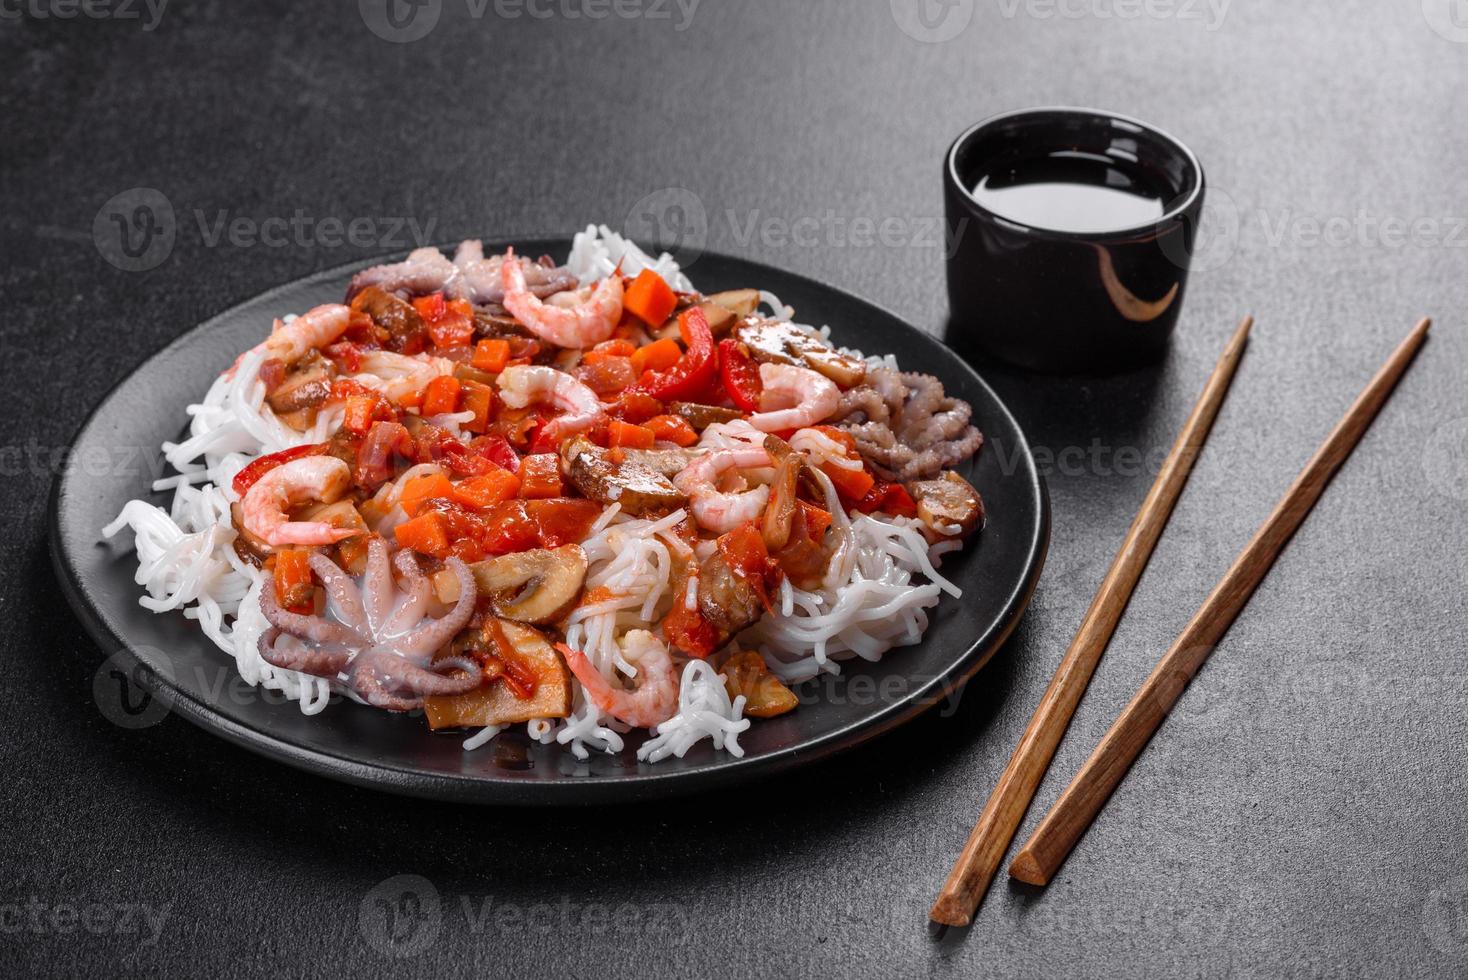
(929, 317, 1431, 926)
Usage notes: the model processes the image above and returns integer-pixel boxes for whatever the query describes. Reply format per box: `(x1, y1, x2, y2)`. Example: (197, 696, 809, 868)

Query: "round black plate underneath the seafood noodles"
(51, 239, 1050, 805)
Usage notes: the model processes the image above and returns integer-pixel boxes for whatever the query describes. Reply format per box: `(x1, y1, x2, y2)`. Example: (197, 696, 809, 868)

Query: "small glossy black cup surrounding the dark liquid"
(944, 109, 1204, 373)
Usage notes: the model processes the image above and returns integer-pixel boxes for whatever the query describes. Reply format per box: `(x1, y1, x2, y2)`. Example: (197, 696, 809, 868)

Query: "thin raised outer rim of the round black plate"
(47, 243, 1051, 807)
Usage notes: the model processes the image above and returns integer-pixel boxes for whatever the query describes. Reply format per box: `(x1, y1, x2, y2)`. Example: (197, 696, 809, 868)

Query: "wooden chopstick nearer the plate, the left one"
(928, 317, 1254, 926)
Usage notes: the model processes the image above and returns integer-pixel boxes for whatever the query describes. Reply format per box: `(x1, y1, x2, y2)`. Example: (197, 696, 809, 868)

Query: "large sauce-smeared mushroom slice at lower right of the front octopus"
(423, 619, 571, 731)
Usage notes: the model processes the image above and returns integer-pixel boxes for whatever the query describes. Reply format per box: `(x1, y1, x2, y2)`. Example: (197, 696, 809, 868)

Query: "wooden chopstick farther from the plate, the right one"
(1010, 320, 1431, 885)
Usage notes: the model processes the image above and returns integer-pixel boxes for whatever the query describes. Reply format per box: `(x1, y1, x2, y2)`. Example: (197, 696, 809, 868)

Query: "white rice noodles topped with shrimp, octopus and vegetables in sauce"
(103, 226, 984, 763)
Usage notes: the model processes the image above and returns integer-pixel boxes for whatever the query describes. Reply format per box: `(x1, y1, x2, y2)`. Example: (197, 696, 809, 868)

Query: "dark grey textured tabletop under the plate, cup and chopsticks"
(0, 0, 1468, 977)
